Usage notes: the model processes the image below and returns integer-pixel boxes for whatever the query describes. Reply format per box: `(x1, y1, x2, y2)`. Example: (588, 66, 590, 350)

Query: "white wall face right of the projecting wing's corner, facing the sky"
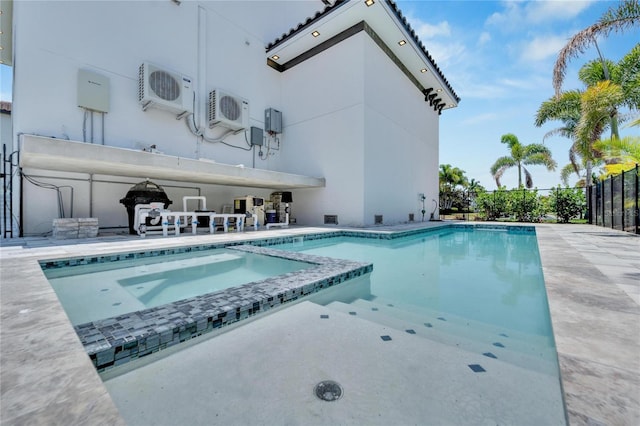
(364, 40, 439, 224)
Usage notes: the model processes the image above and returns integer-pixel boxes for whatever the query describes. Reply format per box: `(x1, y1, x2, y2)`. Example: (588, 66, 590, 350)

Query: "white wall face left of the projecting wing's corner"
(281, 33, 366, 225)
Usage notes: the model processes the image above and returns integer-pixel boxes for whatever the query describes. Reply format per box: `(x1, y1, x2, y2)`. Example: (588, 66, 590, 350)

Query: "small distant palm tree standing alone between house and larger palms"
(491, 133, 556, 188)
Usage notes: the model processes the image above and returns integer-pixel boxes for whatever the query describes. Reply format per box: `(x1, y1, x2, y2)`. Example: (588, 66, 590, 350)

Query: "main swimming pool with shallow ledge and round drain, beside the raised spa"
(102, 226, 566, 425)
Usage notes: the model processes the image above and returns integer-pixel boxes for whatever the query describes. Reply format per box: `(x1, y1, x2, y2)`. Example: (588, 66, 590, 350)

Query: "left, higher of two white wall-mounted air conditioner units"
(138, 62, 193, 118)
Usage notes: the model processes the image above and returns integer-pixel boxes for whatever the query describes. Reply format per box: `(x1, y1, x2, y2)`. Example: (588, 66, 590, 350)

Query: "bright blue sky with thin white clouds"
(0, 0, 640, 189)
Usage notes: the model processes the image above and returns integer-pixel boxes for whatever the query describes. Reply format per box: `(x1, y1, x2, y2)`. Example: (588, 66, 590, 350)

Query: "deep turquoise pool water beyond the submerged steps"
(277, 230, 552, 336)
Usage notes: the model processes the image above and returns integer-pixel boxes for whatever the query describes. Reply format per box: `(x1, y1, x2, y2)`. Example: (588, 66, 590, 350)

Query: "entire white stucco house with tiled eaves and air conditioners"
(3, 0, 460, 236)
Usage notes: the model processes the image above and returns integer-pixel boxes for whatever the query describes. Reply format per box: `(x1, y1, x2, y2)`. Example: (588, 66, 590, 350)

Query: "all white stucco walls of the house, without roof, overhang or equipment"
(8, 0, 438, 235)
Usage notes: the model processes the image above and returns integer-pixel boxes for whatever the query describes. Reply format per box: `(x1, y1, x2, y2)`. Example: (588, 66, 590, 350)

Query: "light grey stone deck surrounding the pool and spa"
(0, 223, 640, 425)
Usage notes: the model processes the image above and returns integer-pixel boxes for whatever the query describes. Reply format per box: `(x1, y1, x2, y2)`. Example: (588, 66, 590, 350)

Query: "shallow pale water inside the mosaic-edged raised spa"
(44, 249, 312, 325)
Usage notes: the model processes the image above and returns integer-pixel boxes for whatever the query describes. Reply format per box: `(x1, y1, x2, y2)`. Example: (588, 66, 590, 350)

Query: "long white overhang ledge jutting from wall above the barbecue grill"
(20, 135, 325, 189)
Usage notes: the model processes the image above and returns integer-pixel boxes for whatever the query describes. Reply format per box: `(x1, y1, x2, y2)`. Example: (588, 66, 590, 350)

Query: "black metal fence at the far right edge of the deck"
(587, 164, 640, 234)
